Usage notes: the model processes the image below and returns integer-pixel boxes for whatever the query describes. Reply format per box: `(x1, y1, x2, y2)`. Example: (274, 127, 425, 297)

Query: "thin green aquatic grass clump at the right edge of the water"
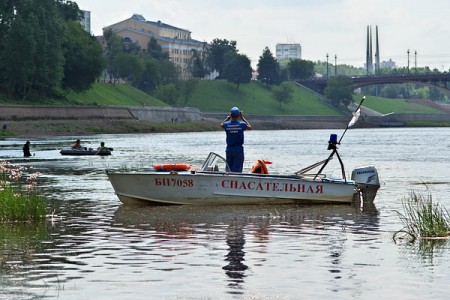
(394, 192, 450, 241)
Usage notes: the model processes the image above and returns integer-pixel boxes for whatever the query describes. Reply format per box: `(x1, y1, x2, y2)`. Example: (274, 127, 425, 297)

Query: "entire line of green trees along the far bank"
(0, 0, 441, 106)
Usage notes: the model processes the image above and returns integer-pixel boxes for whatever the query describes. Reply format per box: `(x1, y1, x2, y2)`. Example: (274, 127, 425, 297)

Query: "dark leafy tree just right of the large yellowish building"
(208, 39, 238, 78)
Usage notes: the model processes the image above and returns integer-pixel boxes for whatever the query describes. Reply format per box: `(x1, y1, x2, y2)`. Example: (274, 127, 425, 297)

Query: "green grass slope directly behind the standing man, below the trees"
(184, 80, 342, 116)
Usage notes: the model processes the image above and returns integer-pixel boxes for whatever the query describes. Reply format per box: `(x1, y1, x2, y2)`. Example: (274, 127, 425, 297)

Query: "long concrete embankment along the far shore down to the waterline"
(0, 105, 450, 136)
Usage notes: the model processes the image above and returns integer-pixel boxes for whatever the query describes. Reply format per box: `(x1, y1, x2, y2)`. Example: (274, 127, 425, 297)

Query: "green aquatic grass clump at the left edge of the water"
(0, 160, 47, 222)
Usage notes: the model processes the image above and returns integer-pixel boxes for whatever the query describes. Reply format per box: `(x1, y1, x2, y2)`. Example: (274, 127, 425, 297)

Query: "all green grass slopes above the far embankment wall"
(0, 80, 443, 116)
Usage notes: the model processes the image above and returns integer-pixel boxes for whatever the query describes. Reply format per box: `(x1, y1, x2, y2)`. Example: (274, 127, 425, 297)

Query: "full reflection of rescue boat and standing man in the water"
(113, 203, 380, 294)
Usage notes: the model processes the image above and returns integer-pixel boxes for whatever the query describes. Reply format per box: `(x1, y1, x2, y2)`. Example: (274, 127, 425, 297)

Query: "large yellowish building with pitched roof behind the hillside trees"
(103, 14, 206, 79)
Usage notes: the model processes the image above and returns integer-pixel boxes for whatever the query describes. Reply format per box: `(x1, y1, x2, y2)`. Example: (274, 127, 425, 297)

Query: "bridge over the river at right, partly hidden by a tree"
(295, 72, 450, 94)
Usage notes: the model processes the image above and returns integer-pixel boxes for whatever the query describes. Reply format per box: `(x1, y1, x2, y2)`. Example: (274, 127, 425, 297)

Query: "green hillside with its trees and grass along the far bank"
(0, 0, 449, 115)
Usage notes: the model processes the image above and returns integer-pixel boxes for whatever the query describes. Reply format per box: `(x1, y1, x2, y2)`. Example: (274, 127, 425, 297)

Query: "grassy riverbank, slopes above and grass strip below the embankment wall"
(0, 80, 449, 138)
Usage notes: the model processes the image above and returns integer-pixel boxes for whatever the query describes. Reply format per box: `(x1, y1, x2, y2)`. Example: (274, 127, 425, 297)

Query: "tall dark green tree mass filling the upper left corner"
(0, 0, 105, 99)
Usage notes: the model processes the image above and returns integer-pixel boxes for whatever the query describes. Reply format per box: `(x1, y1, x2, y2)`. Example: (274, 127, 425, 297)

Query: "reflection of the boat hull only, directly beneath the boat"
(114, 203, 379, 234)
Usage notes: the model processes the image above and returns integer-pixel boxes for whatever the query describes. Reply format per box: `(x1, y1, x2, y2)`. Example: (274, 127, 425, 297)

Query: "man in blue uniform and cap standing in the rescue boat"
(220, 107, 252, 172)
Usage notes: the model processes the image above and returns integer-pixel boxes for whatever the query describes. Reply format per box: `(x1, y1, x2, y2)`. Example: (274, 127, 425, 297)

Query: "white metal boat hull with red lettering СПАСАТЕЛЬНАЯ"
(107, 171, 358, 205)
